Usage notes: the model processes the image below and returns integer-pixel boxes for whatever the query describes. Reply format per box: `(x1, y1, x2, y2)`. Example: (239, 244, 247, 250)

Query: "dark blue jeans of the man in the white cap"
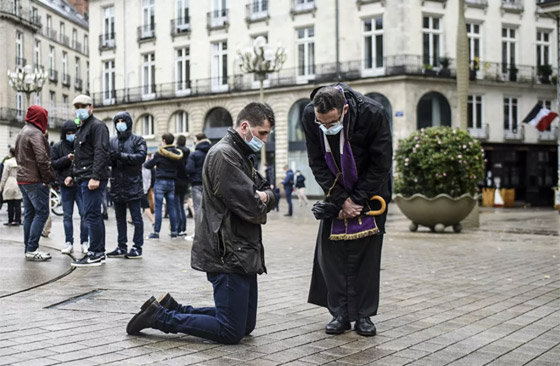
(79, 179, 107, 254)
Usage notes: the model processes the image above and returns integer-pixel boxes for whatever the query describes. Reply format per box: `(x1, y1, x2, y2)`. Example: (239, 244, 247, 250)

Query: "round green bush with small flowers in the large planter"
(395, 127, 484, 198)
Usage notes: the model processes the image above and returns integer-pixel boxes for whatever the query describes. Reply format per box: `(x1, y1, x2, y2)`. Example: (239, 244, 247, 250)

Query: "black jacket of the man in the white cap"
(72, 115, 109, 182)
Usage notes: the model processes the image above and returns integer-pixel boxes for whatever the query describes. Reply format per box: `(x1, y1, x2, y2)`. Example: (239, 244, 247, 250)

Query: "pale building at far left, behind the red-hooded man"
(0, 0, 89, 157)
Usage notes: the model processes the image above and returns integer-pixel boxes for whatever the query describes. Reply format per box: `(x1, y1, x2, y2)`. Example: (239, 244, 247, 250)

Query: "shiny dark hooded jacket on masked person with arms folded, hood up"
(110, 112, 148, 202)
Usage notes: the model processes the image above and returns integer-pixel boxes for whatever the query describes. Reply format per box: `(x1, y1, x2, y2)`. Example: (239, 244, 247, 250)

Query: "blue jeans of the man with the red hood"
(19, 183, 50, 252)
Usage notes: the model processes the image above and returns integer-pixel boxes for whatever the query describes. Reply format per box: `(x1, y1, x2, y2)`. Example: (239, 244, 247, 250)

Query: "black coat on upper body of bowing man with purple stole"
(302, 84, 393, 229)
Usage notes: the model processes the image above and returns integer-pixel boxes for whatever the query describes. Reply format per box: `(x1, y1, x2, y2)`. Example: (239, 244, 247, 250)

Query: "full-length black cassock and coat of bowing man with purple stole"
(302, 84, 392, 321)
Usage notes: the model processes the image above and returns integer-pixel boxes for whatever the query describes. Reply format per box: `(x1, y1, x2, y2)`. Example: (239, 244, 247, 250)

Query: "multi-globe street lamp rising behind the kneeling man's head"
(237, 36, 286, 174)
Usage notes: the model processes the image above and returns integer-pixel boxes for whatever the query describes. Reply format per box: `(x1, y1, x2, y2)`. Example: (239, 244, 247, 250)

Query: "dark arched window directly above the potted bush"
(416, 92, 451, 129)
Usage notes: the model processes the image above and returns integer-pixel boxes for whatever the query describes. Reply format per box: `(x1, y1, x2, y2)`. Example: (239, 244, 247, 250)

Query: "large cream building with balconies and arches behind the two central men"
(90, 0, 558, 204)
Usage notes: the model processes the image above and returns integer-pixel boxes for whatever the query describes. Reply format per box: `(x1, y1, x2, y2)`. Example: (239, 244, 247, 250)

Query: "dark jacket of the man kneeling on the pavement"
(191, 128, 276, 274)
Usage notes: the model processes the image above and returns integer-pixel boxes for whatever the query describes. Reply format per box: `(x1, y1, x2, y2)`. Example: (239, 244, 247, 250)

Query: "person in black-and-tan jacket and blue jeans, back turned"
(144, 132, 183, 239)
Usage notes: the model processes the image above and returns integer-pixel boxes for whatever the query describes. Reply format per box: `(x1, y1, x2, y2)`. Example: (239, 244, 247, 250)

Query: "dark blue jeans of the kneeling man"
(154, 273, 258, 344)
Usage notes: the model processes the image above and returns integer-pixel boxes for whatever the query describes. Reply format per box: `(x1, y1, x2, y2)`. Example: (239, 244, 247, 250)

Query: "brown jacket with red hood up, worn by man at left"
(15, 105, 54, 184)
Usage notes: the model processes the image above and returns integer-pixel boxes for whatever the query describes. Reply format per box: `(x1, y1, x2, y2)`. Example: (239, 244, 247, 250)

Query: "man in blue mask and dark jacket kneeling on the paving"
(127, 103, 274, 344)
